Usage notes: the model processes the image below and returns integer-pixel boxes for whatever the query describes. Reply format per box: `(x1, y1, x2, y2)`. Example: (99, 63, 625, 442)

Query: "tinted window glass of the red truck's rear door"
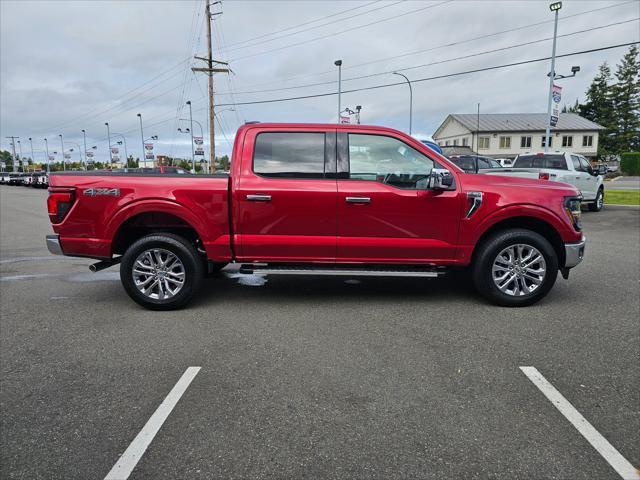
(253, 132, 325, 178)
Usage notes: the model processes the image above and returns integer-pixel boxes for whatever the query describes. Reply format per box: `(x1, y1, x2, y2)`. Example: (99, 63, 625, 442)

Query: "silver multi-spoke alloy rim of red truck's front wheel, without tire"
(491, 243, 547, 297)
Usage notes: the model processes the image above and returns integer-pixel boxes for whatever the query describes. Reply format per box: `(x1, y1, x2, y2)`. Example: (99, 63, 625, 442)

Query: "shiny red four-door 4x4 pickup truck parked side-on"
(47, 124, 585, 310)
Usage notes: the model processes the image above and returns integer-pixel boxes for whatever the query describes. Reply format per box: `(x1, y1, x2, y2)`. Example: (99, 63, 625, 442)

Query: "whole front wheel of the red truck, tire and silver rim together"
(473, 229, 558, 307)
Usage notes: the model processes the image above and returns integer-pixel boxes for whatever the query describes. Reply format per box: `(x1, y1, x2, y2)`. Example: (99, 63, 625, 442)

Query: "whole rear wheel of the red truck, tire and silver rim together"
(120, 233, 203, 310)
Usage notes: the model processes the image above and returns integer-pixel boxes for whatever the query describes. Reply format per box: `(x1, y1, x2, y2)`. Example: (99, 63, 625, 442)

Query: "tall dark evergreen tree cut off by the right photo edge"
(611, 45, 640, 154)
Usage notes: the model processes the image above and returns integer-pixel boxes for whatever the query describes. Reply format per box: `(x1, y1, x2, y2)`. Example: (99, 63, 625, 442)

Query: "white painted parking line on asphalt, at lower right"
(520, 367, 640, 480)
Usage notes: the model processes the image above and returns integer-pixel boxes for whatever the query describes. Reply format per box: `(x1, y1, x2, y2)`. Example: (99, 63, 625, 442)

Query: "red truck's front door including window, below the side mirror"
(337, 130, 461, 263)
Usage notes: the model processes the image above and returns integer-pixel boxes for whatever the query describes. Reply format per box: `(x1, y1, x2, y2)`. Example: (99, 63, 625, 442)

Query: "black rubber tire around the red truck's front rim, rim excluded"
(472, 229, 558, 307)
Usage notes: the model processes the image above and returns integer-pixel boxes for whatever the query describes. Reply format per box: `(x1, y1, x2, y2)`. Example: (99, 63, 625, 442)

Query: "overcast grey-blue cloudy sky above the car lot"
(0, 0, 640, 161)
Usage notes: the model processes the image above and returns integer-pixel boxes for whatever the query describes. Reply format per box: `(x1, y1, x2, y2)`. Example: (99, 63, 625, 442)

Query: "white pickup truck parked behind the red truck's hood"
(479, 152, 604, 212)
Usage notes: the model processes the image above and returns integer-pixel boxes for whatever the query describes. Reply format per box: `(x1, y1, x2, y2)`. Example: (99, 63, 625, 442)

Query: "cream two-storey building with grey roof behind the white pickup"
(433, 113, 604, 158)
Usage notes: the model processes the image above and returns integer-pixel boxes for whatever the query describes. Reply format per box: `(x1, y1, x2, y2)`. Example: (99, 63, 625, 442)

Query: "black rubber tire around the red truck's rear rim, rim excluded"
(120, 233, 204, 310)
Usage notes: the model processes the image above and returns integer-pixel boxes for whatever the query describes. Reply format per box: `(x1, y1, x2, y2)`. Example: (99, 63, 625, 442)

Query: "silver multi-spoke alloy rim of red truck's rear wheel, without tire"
(132, 248, 185, 300)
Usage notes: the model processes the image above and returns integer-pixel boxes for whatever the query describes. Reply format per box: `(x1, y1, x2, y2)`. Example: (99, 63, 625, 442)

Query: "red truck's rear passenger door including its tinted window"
(234, 127, 337, 262)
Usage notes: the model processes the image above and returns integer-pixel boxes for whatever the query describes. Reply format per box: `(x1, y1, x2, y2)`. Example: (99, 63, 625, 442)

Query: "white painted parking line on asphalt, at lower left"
(104, 367, 200, 480)
